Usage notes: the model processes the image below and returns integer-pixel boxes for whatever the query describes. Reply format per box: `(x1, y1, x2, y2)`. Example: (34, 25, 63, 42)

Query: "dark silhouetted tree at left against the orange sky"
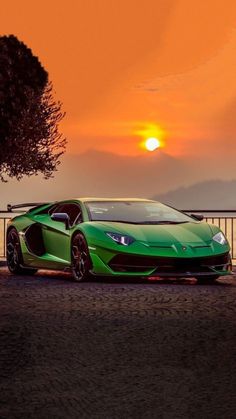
(0, 35, 66, 180)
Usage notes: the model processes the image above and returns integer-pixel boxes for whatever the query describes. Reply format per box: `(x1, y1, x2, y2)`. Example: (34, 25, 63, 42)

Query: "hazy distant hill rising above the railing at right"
(153, 180, 236, 209)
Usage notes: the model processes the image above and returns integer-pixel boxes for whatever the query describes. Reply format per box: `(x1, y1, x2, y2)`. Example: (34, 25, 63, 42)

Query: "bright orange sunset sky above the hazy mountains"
(0, 0, 236, 157)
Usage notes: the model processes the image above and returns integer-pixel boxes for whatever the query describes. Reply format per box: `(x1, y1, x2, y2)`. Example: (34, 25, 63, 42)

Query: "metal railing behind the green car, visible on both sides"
(0, 210, 236, 264)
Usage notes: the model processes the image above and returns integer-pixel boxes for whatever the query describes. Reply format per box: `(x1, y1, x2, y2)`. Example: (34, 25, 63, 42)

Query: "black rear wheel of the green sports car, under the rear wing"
(6, 228, 37, 275)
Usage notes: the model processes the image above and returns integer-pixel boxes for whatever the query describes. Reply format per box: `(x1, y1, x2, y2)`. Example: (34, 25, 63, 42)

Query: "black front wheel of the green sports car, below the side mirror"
(71, 233, 92, 282)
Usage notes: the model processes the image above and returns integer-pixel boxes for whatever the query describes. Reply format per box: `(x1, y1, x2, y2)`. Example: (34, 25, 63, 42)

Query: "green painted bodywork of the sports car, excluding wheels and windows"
(8, 198, 231, 277)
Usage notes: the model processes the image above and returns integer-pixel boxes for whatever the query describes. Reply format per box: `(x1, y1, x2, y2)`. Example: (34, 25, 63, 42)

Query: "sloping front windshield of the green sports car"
(86, 201, 194, 224)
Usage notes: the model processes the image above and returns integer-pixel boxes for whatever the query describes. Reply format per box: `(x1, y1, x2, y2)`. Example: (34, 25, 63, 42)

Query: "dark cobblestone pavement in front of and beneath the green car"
(0, 267, 236, 419)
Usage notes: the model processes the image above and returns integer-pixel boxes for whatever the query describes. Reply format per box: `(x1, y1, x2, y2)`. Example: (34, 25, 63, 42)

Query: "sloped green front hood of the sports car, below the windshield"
(95, 222, 213, 244)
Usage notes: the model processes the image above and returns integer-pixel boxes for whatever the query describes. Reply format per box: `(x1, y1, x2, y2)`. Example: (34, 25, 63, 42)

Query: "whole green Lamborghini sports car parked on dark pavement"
(6, 198, 232, 282)
